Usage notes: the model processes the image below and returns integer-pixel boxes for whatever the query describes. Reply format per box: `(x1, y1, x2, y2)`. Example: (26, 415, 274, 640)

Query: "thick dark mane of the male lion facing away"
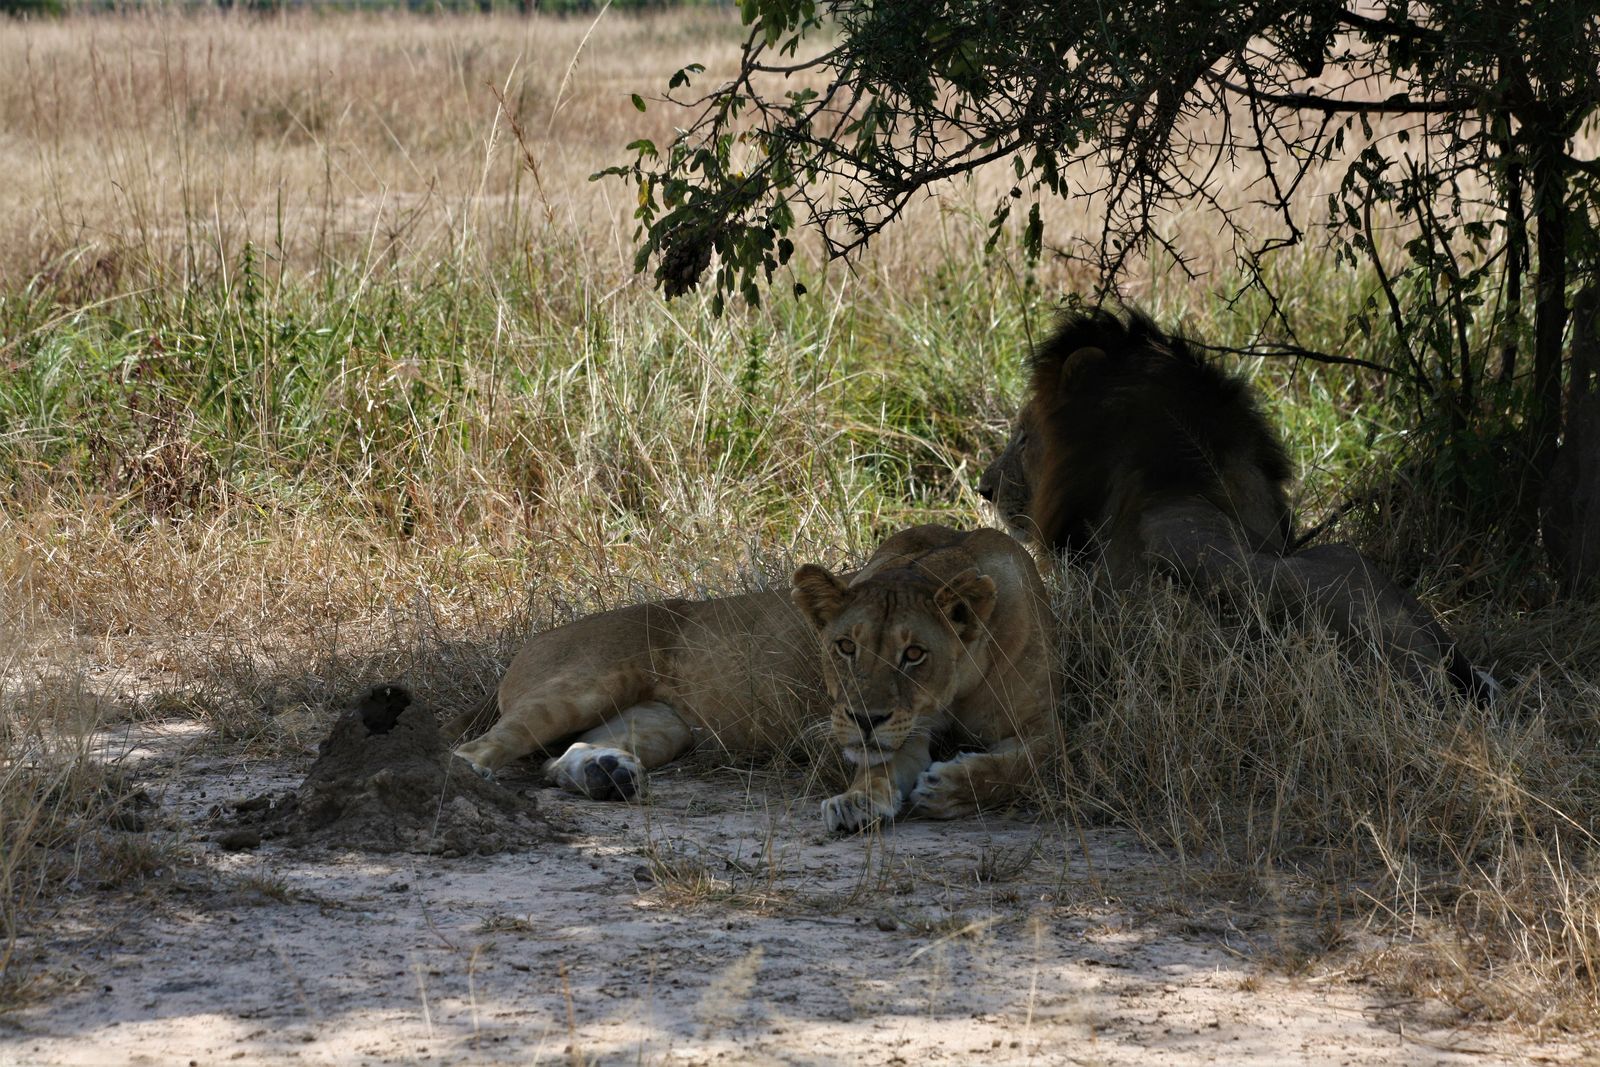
(1032, 310, 1293, 550)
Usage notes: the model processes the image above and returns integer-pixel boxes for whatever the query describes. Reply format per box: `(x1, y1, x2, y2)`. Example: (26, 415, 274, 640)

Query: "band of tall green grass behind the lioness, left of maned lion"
(0, 248, 1026, 541)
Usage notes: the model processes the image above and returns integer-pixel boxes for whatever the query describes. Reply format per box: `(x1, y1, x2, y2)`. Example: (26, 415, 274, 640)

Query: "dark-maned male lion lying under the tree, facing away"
(978, 310, 1499, 701)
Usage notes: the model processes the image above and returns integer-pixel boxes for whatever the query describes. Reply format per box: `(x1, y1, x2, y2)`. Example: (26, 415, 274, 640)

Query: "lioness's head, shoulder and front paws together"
(794, 526, 1056, 830)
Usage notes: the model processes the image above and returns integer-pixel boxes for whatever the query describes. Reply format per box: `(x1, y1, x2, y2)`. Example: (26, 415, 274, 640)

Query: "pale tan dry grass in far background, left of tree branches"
(0, 13, 736, 283)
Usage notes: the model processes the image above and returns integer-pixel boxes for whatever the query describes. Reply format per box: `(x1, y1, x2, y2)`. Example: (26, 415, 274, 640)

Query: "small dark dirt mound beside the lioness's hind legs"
(218, 685, 554, 856)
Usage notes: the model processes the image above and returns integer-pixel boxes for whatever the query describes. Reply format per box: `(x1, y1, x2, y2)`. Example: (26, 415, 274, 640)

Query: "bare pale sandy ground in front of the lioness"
(0, 728, 1595, 1065)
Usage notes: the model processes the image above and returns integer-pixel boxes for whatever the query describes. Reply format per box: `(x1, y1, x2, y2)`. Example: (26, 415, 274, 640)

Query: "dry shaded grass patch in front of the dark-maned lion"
(1058, 571, 1600, 1029)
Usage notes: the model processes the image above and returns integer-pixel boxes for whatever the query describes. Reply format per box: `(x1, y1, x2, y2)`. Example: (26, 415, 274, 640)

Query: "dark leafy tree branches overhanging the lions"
(605, 0, 1600, 489)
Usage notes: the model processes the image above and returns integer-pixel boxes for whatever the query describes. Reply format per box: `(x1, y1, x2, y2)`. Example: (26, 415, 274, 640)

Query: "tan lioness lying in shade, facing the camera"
(450, 526, 1054, 830)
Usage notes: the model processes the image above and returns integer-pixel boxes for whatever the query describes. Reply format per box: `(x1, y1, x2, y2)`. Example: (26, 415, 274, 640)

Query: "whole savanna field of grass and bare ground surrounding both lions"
(9, 11, 1600, 1064)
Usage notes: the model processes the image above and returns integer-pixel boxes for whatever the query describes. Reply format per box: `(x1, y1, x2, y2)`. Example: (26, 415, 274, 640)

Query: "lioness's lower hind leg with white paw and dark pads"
(544, 701, 693, 800)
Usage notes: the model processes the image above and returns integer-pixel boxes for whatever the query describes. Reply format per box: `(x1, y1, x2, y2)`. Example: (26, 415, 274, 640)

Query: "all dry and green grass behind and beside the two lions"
(0, 2, 1600, 1027)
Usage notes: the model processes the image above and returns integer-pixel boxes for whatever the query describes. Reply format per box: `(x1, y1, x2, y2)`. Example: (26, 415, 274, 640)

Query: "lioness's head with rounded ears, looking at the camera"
(792, 563, 995, 766)
